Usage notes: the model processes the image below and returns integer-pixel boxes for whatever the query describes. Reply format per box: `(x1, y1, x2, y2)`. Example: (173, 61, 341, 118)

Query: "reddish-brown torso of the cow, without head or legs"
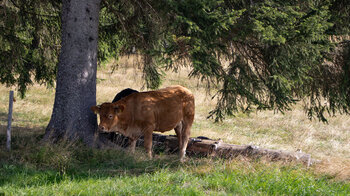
(123, 86, 194, 132)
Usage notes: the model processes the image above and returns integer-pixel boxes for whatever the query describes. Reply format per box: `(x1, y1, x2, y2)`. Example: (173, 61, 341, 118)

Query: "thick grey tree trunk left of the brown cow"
(44, 0, 100, 145)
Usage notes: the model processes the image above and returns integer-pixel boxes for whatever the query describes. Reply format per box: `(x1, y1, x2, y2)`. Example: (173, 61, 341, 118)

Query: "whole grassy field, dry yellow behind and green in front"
(0, 57, 350, 195)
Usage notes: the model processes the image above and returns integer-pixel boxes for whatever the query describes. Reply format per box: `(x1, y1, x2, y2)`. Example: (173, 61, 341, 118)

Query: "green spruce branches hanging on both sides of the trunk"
(0, 0, 350, 121)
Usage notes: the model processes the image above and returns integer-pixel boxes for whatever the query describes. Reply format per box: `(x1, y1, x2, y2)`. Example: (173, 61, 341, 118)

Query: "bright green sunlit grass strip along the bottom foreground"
(0, 165, 350, 195)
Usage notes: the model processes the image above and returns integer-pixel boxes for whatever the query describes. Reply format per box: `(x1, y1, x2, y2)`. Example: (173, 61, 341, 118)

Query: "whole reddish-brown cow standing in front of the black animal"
(91, 85, 195, 161)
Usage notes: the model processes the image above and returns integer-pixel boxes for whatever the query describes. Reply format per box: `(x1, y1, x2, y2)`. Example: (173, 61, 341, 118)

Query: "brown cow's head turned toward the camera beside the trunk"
(90, 103, 125, 132)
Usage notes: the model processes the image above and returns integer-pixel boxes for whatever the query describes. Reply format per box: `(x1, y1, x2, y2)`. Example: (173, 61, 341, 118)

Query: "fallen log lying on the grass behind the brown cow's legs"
(105, 133, 317, 166)
